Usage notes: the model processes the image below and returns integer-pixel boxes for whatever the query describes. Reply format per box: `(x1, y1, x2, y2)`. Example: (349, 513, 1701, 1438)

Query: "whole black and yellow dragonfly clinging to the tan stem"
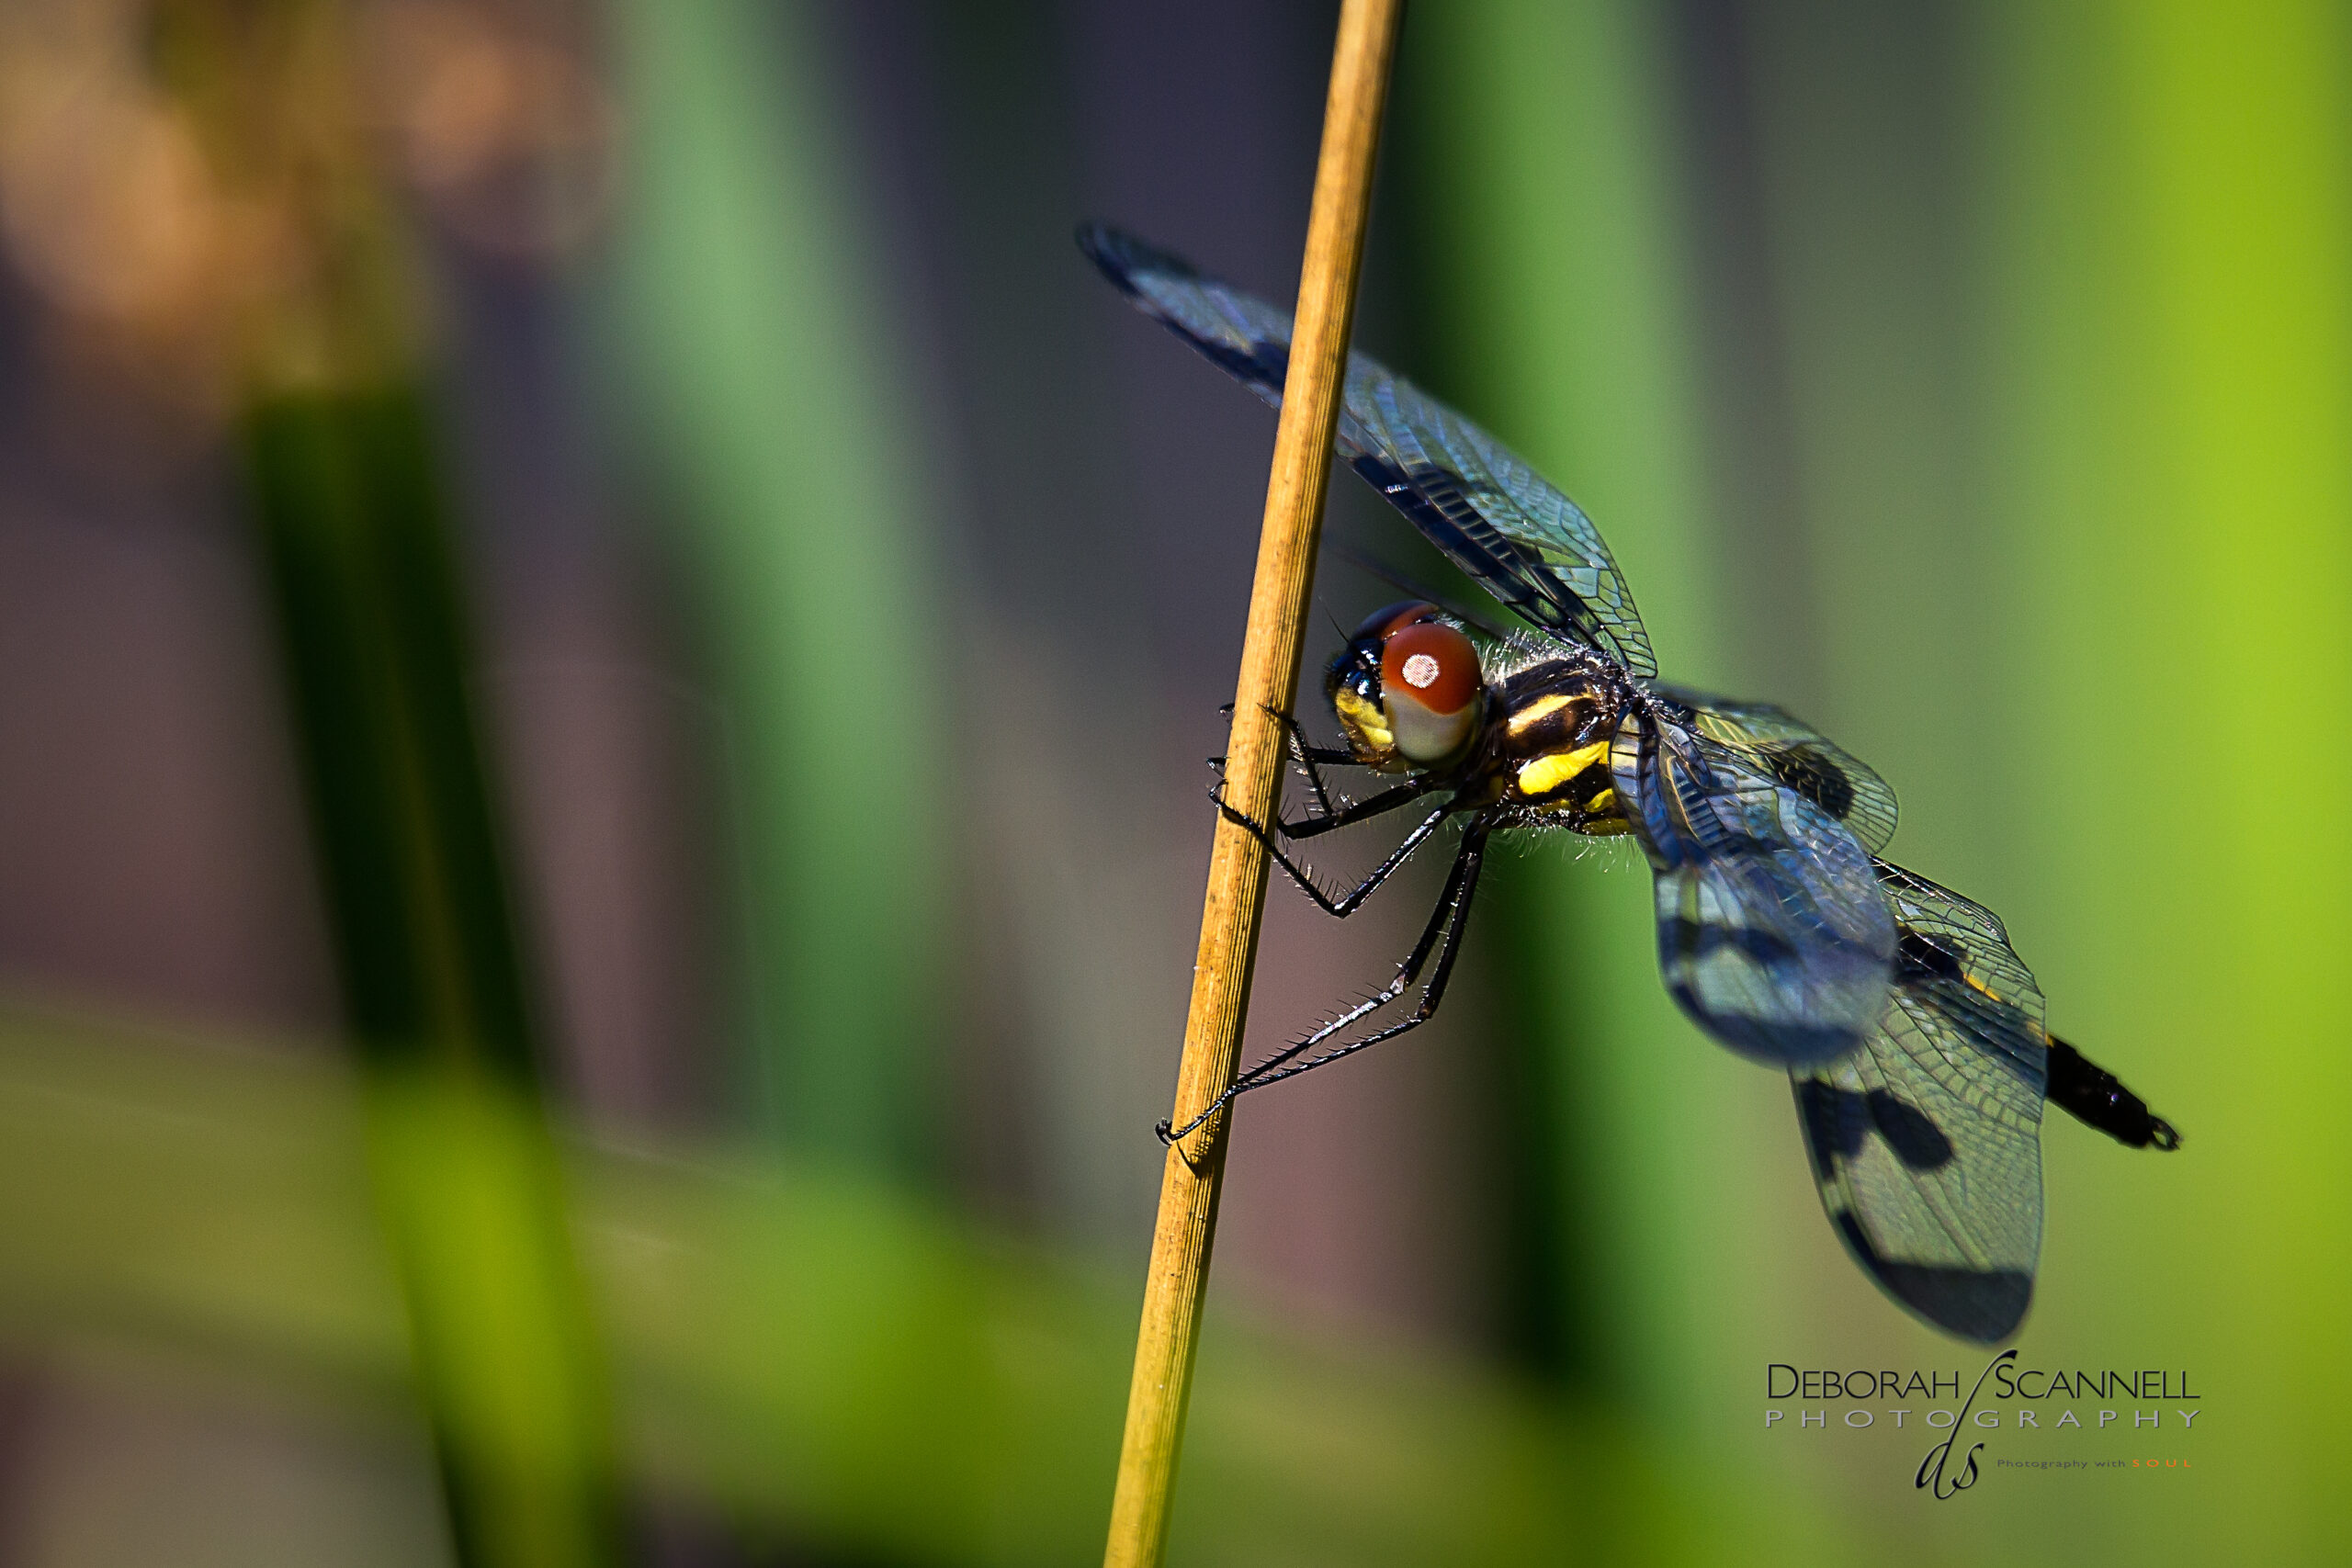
(1077, 223, 2180, 1345)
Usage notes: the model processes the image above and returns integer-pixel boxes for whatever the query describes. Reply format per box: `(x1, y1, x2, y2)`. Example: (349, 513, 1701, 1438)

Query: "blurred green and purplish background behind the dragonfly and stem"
(0, 0, 2352, 1568)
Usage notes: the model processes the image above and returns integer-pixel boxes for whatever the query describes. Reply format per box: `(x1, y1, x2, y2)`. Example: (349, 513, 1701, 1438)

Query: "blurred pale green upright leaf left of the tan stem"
(606, 0, 957, 1176)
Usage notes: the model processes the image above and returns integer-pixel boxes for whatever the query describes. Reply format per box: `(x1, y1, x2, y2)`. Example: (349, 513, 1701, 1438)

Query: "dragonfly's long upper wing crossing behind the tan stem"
(1077, 226, 1658, 674)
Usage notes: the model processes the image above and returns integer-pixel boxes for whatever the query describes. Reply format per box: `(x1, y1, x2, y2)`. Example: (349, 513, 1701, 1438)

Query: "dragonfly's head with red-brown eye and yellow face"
(1324, 600, 1487, 773)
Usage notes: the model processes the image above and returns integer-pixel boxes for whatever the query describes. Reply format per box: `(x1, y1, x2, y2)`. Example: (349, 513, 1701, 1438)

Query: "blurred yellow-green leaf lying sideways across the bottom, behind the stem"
(0, 1013, 1689, 1568)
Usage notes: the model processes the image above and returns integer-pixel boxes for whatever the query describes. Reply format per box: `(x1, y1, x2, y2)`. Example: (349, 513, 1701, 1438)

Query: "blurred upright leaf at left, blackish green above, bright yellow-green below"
(247, 371, 618, 1568)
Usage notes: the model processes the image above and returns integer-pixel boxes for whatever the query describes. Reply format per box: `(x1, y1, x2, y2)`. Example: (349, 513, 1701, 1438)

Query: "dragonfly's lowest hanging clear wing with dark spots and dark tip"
(1790, 861, 2049, 1345)
